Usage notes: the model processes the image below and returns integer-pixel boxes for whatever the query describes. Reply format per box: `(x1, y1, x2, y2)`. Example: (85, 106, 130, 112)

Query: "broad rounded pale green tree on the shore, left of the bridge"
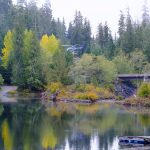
(69, 54, 117, 84)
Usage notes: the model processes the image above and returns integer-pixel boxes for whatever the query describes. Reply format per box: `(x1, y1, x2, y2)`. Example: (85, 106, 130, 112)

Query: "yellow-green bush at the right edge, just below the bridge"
(137, 83, 150, 98)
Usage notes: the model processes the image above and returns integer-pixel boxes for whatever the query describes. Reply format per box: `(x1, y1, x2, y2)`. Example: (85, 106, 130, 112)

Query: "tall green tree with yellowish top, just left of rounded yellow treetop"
(23, 30, 42, 90)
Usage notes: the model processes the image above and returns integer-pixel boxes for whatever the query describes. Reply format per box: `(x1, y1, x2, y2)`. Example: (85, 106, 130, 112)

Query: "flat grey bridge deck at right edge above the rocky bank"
(118, 74, 150, 81)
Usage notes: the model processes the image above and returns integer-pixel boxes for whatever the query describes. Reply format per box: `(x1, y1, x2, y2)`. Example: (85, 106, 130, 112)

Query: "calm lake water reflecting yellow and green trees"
(0, 101, 150, 150)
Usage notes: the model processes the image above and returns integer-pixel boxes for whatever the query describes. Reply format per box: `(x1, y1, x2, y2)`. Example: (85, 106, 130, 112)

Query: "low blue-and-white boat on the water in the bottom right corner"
(119, 136, 150, 145)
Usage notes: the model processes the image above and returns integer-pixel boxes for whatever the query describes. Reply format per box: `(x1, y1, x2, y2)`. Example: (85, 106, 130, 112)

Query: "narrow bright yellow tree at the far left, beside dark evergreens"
(2, 31, 13, 68)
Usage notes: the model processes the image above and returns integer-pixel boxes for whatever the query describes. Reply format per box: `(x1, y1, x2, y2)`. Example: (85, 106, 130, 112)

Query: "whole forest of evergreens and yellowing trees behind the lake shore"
(0, 0, 150, 91)
